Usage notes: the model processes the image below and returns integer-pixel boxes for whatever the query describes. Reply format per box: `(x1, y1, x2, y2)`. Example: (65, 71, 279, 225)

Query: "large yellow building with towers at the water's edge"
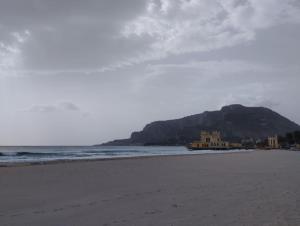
(189, 131, 229, 150)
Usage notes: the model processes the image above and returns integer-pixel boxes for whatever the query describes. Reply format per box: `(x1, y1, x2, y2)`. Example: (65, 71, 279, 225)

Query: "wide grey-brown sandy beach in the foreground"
(0, 151, 300, 226)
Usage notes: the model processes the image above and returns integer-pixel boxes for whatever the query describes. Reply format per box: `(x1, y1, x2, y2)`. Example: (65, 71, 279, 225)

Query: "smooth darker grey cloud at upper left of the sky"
(0, 0, 145, 75)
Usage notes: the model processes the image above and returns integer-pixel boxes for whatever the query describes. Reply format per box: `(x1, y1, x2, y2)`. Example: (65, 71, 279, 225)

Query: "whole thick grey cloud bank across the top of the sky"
(0, 0, 300, 75)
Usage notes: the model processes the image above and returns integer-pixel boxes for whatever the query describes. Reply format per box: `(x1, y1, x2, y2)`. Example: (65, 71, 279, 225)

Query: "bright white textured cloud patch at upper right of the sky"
(118, 0, 300, 66)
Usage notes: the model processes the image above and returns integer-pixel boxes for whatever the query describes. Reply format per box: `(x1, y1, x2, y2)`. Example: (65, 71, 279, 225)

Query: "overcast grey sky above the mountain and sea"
(0, 0, 300, 145)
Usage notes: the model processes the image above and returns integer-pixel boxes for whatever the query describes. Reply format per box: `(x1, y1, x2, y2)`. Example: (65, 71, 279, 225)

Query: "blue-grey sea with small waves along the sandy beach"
(0, 146, 249, 165)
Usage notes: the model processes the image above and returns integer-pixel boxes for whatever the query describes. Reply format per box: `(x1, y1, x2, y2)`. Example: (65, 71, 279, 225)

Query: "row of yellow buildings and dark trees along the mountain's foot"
(188, 131, 300, 151)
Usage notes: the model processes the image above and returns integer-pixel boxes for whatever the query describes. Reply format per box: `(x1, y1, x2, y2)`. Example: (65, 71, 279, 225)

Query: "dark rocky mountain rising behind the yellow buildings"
(102, 104, 300, 145)
